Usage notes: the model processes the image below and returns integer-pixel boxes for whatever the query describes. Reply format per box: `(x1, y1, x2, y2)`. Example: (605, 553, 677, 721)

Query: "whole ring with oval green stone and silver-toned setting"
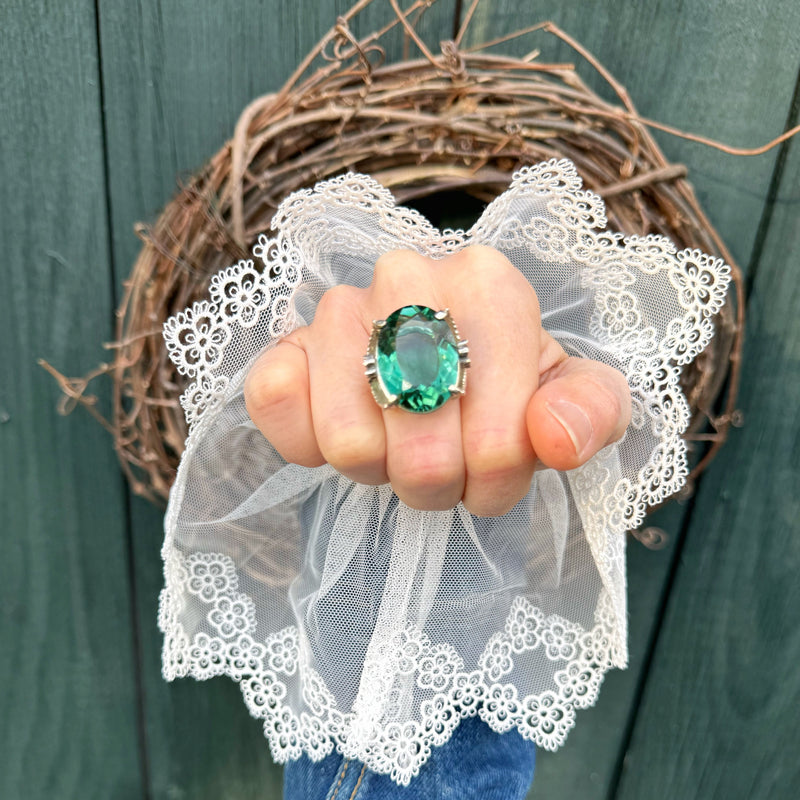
(364, 305, 469, 414)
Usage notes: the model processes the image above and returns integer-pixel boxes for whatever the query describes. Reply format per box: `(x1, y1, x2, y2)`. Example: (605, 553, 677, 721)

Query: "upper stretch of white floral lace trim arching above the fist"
(164, 159, 730, 532)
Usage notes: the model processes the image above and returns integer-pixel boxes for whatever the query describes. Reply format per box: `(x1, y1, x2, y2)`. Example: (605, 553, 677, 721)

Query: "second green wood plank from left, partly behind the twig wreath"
(94, 0, 455, 800)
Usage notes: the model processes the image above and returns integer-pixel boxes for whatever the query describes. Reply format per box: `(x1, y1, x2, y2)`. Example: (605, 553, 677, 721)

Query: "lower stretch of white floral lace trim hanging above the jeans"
(158, 551, 618, 785)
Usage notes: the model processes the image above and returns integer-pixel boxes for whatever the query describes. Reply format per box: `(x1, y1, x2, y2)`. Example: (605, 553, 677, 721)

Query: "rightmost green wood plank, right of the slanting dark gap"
(616, 104, 800, 800)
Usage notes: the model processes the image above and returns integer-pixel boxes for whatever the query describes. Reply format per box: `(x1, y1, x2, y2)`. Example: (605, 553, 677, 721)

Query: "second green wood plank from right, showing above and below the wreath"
(456, 0, 800, 800)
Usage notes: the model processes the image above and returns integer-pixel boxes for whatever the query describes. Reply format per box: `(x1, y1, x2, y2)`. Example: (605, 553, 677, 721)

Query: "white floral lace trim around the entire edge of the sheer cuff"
(160, 160, 730, 783)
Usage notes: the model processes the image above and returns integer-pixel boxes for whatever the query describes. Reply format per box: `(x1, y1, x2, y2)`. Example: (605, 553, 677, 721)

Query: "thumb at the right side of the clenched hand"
(526, 357, 631, 470)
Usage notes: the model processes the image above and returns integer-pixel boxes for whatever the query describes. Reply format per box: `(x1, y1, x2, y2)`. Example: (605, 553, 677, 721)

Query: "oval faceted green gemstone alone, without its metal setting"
(376, 306, 463, 414)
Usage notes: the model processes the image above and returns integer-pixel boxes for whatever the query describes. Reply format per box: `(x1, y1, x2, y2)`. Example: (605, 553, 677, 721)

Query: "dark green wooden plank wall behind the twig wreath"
(0, 0, 800, 800)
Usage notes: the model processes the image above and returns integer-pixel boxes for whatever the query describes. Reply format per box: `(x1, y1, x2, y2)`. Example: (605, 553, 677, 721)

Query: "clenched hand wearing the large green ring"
(244, 246, 631, 516)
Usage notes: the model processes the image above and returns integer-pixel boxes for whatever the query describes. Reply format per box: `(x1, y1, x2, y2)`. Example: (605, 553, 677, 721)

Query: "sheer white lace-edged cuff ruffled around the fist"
(159, 161, 729, 784)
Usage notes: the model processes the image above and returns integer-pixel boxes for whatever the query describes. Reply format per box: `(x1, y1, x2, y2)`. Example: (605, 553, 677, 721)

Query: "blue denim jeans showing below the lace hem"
(283, 717, 536, 800)
